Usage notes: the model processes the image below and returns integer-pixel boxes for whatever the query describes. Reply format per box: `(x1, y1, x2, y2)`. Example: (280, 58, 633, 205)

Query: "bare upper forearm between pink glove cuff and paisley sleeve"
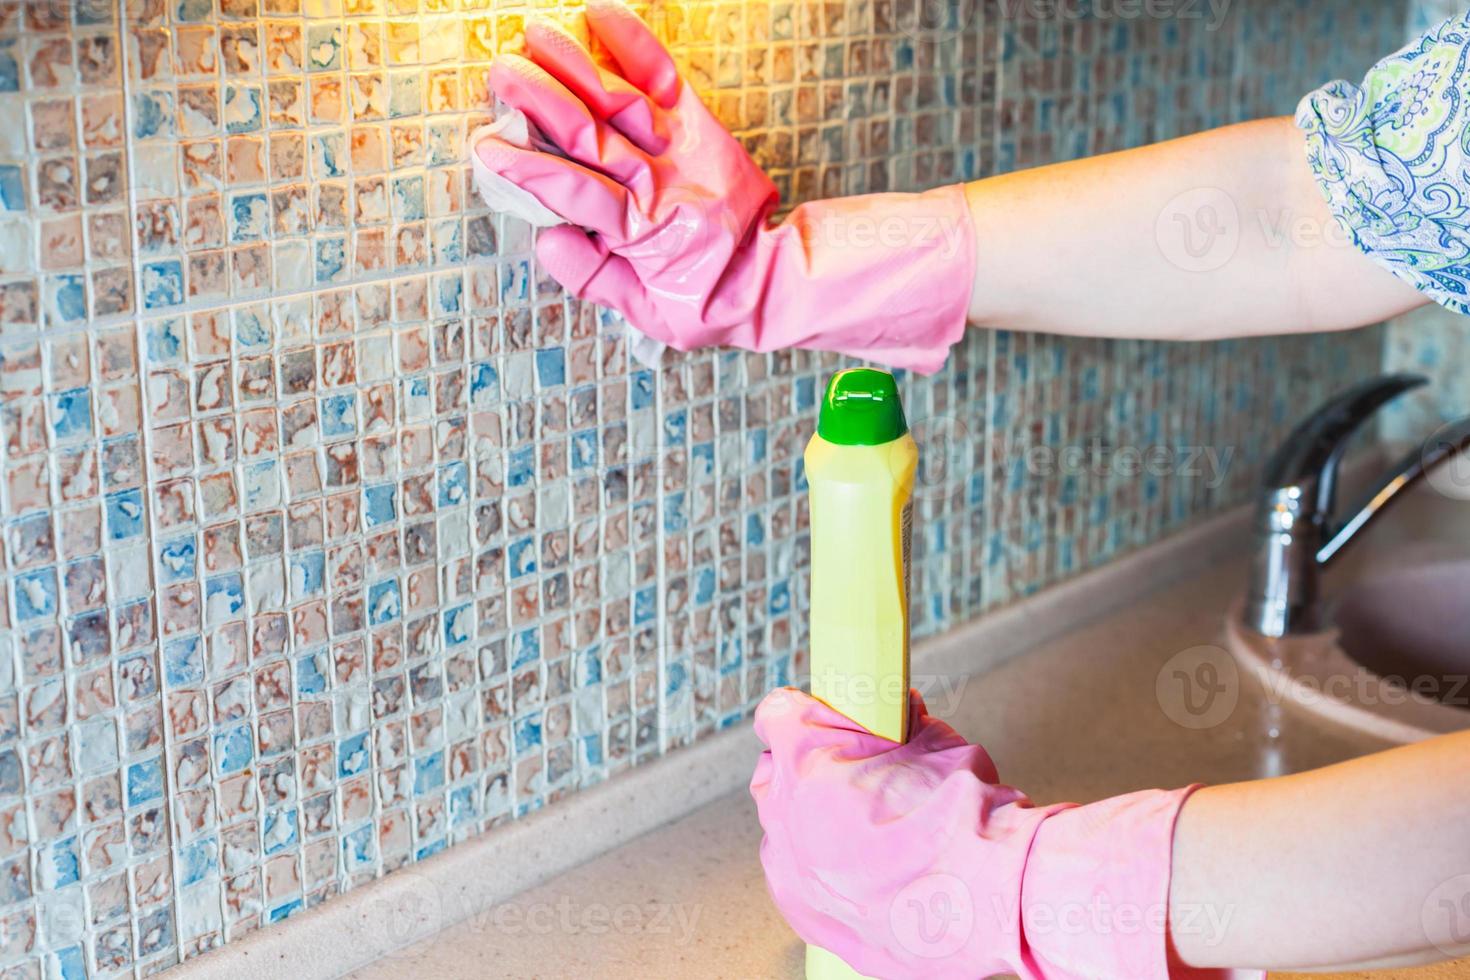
(967, 119, 1424, 339)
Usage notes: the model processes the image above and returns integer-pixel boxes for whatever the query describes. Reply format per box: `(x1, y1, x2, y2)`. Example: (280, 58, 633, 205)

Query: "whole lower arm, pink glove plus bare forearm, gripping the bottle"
(750, 689, 1470, 980)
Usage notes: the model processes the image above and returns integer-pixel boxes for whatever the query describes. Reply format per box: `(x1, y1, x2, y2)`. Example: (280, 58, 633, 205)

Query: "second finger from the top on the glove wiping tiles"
(526, 21, 669, 153)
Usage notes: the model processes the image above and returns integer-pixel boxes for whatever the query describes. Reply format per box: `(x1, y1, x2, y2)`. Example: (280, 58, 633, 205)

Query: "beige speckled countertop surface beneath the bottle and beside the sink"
(341, 561, 1470, 980)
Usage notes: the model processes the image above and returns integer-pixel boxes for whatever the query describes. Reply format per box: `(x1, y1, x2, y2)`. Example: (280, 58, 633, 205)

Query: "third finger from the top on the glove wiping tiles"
(490, 54, 648, 182)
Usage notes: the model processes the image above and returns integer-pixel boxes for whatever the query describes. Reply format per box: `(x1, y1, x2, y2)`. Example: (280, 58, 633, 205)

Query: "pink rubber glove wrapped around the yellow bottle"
(750, 691, 1225, 980)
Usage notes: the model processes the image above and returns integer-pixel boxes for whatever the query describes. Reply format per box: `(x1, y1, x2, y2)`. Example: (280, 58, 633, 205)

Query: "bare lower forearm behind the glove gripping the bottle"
(1170, 732, 1470, 970)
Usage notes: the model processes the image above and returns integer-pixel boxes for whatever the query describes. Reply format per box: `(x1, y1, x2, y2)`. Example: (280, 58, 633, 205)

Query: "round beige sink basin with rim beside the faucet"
(1226, 482, 1470, 742)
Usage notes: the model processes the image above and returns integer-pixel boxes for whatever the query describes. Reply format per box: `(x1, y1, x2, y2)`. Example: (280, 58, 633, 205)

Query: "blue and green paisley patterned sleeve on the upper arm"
(1297, 13, 1470, 313)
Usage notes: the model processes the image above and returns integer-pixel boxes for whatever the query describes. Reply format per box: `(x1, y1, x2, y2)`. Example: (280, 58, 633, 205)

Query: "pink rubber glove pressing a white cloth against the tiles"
(476, 0, 975, 373)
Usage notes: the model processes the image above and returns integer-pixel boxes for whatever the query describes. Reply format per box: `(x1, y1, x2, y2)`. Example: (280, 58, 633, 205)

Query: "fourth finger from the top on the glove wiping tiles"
(475, 137, 628, 241)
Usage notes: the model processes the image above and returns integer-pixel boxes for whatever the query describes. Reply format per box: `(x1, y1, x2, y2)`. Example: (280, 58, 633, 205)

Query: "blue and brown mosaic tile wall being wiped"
(0, 0, 1404, 979)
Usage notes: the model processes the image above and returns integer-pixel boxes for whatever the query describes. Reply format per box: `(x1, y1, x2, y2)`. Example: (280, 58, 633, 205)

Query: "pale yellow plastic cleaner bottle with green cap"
(804, 367, 919, 980)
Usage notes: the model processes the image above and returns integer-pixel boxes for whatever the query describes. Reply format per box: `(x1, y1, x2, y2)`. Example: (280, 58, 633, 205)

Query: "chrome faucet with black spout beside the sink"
(1244, 375, 1470, 636)
